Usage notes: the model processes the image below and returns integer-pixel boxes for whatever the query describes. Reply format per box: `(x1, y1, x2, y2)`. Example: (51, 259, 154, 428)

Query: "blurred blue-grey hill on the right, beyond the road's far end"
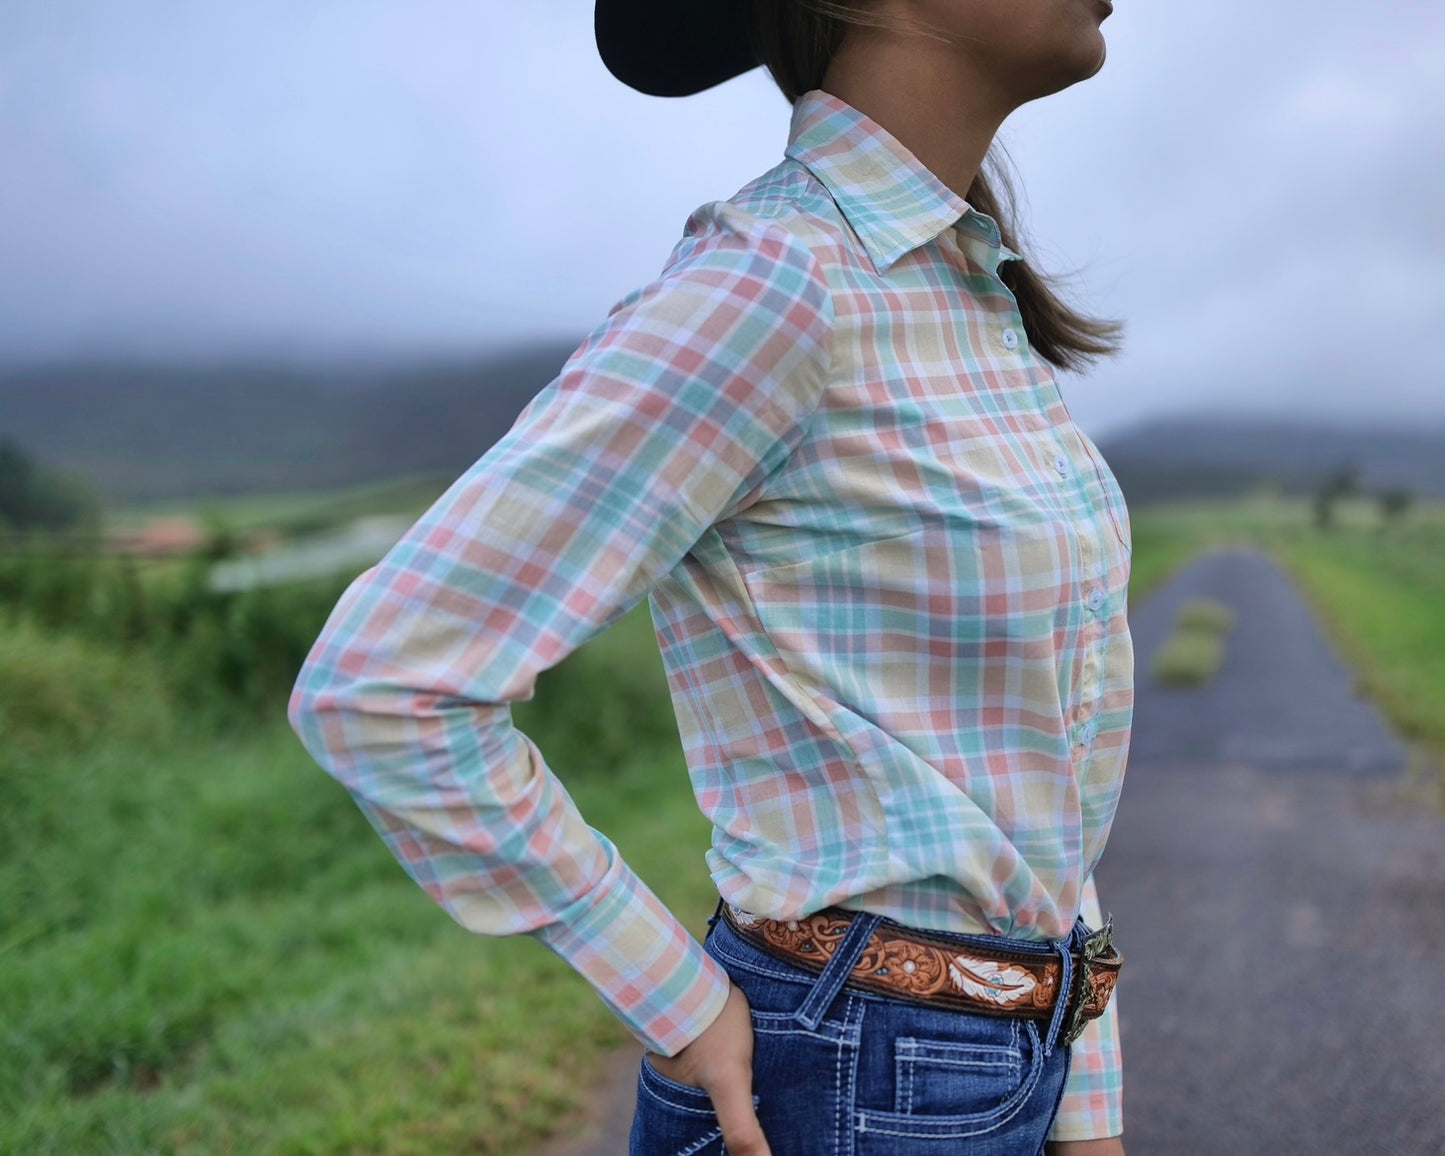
(1098, 415, 1445, 506)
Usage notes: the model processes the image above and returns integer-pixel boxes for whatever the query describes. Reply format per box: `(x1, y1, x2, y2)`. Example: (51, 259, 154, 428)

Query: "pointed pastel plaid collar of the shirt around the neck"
(786, 88, 1017, 273)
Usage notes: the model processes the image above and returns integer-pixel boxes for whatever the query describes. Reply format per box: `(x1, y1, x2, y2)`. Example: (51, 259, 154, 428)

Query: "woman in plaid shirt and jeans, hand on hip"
(290, 0, 1133, 1156)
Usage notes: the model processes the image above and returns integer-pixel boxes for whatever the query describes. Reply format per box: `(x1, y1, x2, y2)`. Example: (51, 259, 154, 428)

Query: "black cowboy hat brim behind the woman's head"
(592, 0, 759, 97)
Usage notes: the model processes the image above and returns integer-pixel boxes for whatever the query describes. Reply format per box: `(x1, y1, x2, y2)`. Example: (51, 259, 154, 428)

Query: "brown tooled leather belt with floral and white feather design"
(723, 903, 1124, 1043)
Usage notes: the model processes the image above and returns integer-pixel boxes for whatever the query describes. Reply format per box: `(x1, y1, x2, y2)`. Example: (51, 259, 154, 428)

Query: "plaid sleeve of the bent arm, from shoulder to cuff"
(289, 202, 832, 1055)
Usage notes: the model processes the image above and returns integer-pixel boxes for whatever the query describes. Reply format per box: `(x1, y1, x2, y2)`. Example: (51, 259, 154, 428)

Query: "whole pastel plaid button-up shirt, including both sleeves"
(290, 91, 1133, 1139)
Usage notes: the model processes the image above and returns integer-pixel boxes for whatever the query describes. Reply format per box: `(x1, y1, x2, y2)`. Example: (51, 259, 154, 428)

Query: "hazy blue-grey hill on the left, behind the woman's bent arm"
(0, 340, 581, 506)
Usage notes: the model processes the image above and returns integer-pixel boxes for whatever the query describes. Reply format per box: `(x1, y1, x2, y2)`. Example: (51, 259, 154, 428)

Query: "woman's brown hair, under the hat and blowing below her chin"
(744, 0, 1123, 370)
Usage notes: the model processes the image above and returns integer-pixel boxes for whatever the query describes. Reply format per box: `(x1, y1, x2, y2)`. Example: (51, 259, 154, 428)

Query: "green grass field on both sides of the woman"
(0, 491, 1445, 1156)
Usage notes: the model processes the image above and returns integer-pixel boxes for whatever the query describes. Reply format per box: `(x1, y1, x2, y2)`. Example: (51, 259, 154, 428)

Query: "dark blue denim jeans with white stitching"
(629, 907, 1087, 1156)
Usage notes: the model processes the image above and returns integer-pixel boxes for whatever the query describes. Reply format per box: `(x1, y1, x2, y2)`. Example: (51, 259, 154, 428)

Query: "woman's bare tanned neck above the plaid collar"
(822, 26, 1016, 198)
